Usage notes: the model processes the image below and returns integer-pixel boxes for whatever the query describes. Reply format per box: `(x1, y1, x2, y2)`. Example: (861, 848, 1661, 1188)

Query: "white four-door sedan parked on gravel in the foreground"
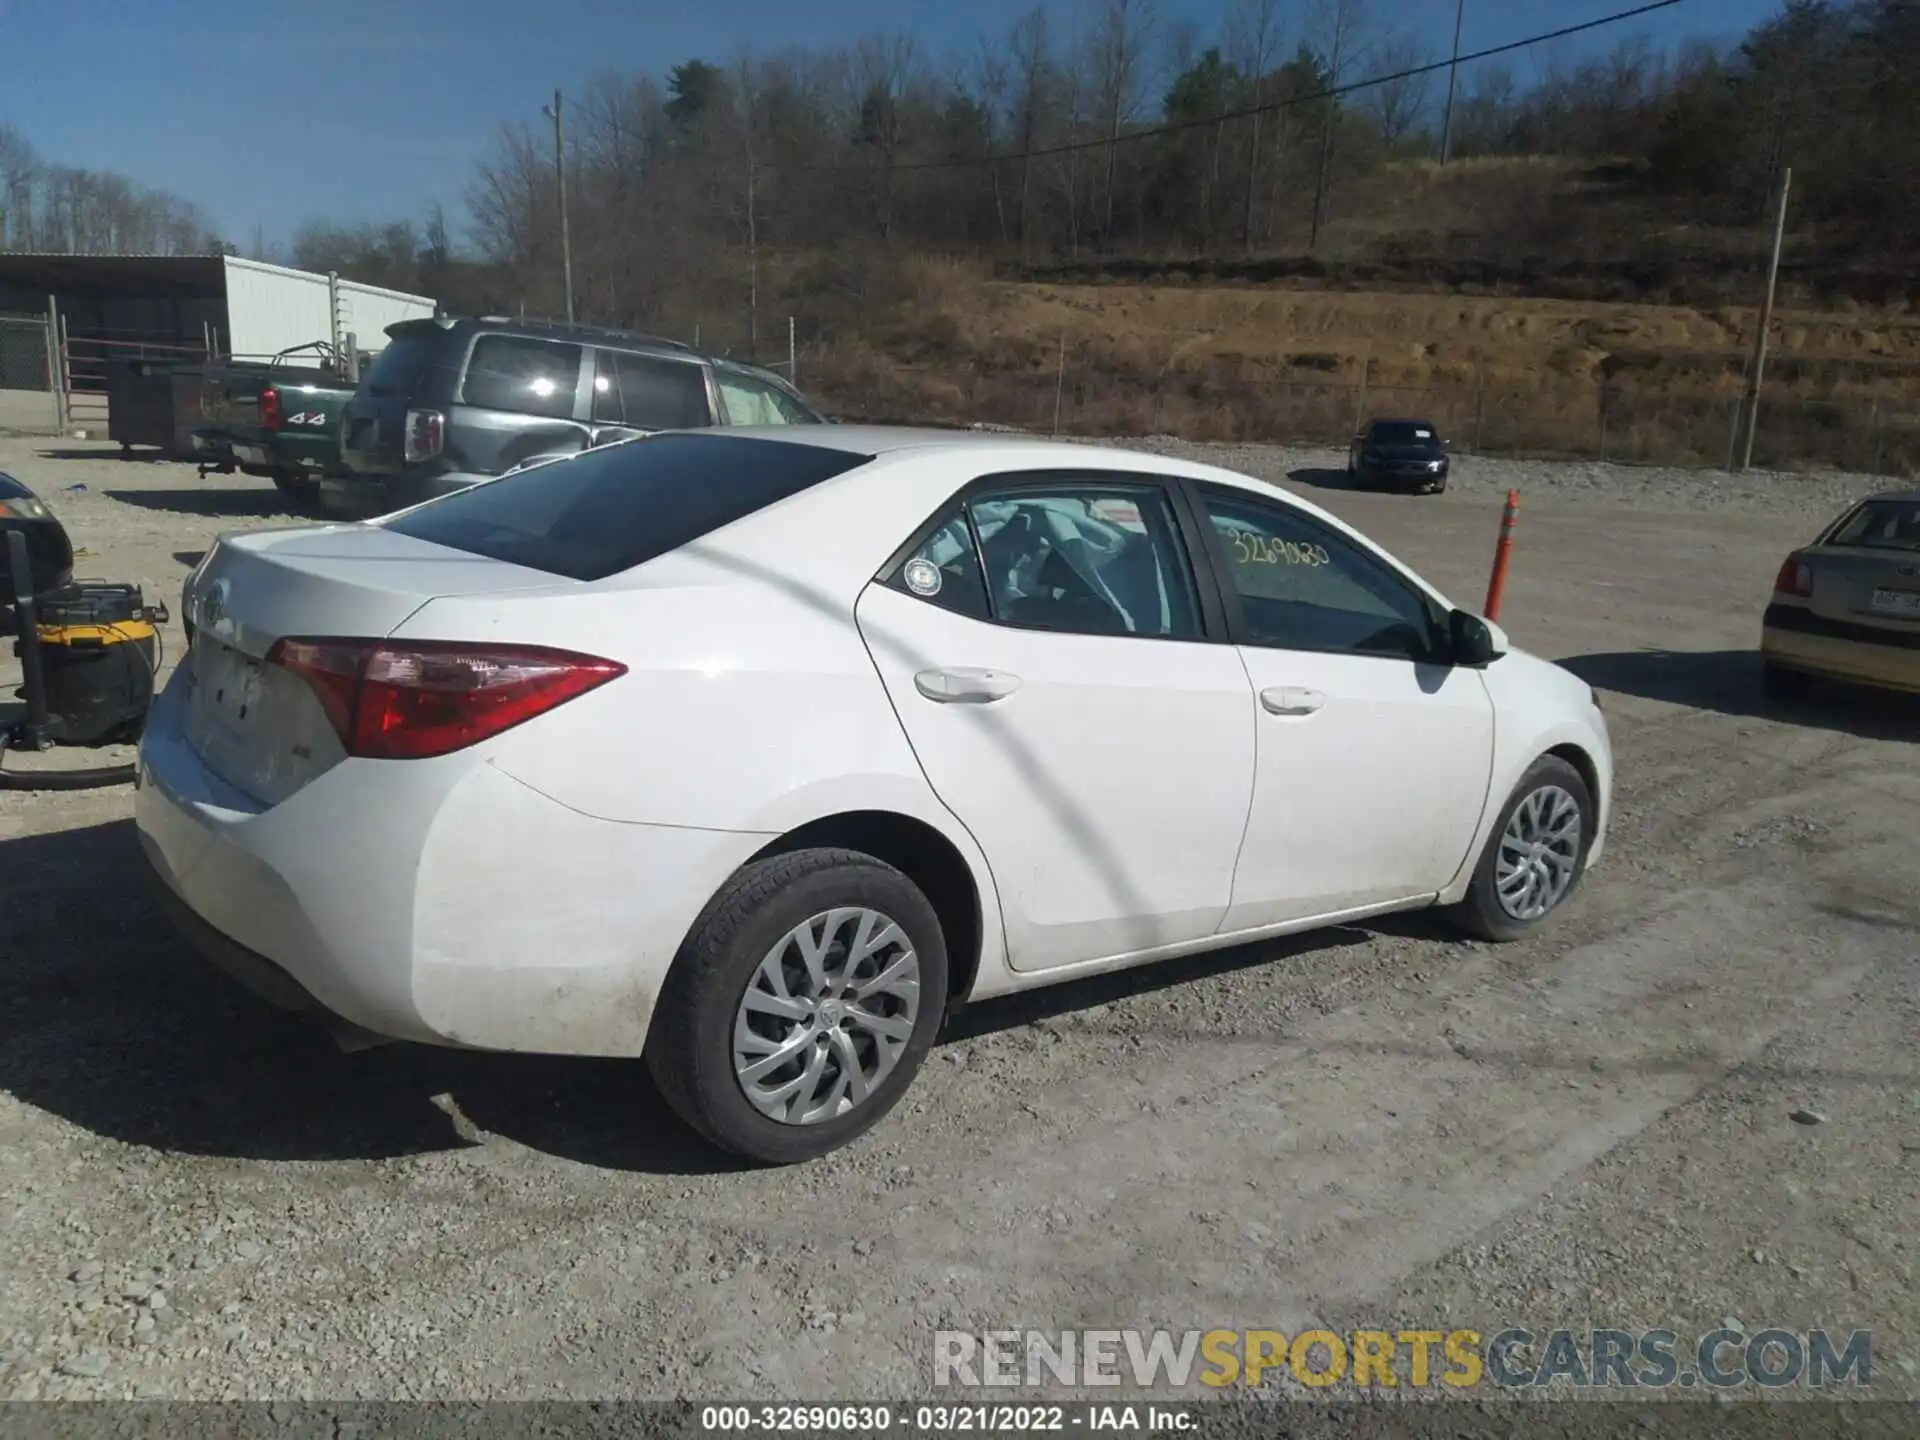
(136, 426, 1613, 1162)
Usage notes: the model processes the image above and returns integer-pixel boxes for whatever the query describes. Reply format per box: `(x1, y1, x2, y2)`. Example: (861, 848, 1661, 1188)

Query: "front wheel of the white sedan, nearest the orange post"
(1448, 755, 1596, 941)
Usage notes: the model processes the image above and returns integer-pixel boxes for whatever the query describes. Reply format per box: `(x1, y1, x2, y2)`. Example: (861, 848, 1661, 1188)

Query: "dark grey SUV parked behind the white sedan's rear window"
(342, 317, 828, 509)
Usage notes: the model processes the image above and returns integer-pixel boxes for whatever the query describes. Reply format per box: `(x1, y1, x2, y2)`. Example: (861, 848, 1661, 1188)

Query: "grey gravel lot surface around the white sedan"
(0, 440, 1920, 1400)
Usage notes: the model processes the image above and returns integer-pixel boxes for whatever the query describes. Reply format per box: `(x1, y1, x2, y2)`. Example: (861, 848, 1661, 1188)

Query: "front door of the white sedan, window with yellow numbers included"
(1194, 484, 1494, 933)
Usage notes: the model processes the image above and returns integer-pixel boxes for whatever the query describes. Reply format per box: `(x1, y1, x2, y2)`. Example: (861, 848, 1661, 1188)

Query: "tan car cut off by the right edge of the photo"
(1761, 490, 1920, 699)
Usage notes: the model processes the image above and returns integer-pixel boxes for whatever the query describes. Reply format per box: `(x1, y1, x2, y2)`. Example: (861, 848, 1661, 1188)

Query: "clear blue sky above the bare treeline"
(0, 0, 1780, 244)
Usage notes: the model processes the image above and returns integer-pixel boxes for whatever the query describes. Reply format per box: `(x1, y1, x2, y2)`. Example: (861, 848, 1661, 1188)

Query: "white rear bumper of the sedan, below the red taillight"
(134, 685, 766, 1056)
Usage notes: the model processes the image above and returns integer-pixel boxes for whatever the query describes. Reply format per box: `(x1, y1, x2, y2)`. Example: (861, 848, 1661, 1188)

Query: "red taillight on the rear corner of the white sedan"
(267, 639, 626, 760)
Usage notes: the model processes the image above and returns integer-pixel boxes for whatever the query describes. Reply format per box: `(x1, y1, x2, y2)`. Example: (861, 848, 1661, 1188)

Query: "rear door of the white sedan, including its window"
(858, 474, 1256, 972)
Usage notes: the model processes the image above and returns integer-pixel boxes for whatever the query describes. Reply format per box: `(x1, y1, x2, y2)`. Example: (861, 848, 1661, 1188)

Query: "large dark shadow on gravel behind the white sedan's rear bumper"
(0, 820, 735, 1175)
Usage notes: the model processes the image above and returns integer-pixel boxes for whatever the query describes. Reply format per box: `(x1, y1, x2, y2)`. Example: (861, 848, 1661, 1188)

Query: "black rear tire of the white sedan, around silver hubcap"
(647, 849, 947, 1165)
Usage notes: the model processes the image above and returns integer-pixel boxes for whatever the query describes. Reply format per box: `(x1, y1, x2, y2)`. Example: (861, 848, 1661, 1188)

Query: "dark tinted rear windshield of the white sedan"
(384, 432, 872, 580)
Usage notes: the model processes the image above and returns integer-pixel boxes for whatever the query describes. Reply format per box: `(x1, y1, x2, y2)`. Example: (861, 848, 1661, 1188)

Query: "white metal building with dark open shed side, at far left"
(0, 253, 438, 428)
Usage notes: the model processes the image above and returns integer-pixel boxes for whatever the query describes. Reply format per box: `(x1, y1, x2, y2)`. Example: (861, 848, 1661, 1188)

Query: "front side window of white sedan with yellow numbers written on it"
(1202, 486, 1442, 660)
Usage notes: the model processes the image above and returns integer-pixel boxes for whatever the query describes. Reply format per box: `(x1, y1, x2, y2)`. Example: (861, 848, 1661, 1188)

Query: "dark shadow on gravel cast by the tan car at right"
(1559, 651, 1920, 741)
